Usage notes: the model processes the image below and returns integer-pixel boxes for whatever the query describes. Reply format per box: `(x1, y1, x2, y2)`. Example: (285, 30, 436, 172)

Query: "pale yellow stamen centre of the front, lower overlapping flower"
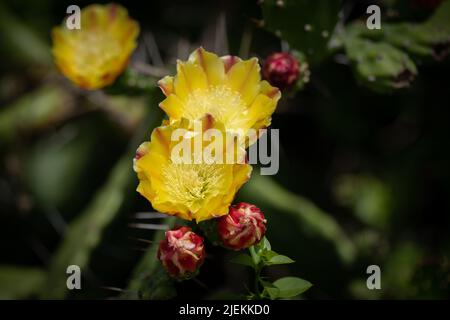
(163, 163, 226, 211)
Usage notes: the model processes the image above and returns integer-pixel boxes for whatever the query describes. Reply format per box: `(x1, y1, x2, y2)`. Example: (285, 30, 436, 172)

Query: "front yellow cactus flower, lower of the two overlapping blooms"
(134, 115, 252, 222)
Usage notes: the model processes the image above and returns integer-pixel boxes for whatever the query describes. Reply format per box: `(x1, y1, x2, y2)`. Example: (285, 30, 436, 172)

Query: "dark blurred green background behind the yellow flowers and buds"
(0, 0, 450, 299)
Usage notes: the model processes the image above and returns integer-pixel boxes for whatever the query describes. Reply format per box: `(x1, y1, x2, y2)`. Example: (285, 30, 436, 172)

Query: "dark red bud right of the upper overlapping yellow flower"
(263, 52, 300, 90)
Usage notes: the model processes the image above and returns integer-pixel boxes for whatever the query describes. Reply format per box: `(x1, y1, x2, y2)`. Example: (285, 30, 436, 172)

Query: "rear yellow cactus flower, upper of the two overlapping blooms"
(158, 48, 281, 142)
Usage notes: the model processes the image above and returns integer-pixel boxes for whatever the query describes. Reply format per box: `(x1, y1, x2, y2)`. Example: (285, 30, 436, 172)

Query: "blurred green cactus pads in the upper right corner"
(334, 2, 450, 92)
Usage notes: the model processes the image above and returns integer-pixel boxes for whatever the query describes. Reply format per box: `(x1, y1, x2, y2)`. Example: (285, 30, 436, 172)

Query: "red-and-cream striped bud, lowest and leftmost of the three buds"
(158, 227, 205, 280)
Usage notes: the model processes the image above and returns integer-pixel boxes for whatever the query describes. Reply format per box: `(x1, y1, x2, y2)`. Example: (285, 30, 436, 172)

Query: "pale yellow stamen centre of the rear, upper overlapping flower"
(185, 85, 248, 130)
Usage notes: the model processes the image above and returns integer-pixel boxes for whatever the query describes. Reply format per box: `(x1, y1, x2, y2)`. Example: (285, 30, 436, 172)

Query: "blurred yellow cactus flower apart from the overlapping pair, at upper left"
(52, 4, 139, 89)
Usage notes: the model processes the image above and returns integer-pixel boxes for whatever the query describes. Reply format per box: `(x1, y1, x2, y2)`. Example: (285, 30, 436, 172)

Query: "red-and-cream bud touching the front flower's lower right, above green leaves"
(218, 202, 267, 250)
